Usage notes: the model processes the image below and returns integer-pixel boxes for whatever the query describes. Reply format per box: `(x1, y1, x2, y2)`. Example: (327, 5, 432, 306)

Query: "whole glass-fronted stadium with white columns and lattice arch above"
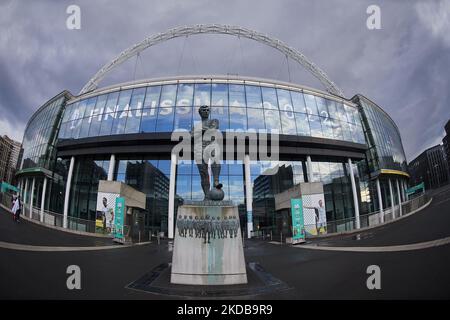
(16, 25, 409, 238)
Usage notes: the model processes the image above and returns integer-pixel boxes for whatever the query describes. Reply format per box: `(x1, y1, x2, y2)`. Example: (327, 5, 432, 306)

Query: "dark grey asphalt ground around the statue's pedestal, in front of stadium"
(0, 186, 450, 299)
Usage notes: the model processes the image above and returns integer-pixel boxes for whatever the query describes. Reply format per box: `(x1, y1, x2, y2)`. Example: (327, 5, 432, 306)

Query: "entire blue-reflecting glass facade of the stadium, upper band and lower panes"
(16, 79, 412, 233)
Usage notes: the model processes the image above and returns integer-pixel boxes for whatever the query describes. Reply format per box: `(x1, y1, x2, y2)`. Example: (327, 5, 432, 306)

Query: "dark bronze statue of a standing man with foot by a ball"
(195, 106, 225, 201)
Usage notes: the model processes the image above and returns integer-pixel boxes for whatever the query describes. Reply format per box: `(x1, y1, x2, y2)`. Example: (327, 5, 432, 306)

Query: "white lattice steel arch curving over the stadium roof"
(79, 24, 344, 97)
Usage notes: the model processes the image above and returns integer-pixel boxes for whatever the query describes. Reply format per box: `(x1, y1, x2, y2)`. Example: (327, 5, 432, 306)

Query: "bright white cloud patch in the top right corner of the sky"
(415, 0, 450, 47)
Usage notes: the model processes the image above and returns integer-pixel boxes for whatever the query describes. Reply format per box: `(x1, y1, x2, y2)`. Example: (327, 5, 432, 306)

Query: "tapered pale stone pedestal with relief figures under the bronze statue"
(170, 202, 247, 285)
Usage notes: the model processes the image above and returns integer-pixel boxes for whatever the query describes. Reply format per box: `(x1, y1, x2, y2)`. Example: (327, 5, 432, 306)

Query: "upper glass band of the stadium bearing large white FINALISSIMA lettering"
(59, 82, 365, 144)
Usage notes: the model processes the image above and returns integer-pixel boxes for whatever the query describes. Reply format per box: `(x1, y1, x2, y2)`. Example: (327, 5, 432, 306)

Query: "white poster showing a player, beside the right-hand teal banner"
(302, 193, 327, 235)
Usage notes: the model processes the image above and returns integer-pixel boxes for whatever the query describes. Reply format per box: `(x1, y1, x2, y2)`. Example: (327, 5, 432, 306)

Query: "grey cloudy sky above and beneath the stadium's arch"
(0, 0, 450, 161)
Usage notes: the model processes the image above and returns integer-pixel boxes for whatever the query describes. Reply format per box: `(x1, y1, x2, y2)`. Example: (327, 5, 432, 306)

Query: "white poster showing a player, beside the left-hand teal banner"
(95, 192, 119, 233)
